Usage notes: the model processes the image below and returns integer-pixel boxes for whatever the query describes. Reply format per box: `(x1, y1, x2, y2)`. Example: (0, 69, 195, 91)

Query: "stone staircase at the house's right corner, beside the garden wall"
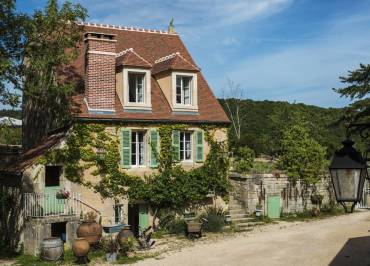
(229, 195, 264, 231)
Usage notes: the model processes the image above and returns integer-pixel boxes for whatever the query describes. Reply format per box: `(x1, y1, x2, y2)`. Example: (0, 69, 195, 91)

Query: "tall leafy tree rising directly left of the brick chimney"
(23, 0, 86, 149)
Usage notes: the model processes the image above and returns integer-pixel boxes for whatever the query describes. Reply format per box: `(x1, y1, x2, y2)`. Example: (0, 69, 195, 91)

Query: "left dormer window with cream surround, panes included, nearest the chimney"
(122, 67, 152, 112)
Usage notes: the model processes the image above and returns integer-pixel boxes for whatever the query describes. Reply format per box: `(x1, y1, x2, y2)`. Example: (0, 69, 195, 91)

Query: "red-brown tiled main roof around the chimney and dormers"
(73, 24, 230, 123)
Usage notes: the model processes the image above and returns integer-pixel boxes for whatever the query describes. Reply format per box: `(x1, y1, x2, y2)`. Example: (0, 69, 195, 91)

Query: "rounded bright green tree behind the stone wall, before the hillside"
(278, 123, 327, 184)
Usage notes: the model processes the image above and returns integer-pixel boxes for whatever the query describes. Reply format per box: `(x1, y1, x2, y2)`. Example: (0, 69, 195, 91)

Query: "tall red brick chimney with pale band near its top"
(84, 32, 117, 114)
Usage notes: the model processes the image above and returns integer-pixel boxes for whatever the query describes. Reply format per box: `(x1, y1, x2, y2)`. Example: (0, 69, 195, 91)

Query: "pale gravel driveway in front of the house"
(136, 211, 370, 266)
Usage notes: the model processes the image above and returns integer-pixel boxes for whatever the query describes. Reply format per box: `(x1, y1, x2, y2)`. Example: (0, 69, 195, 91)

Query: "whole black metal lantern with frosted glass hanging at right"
(329, 139, 367, 212)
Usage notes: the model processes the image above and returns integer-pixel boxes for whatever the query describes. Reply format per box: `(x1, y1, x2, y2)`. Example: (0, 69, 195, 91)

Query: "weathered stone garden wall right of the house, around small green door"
(230, 174, 334, 214)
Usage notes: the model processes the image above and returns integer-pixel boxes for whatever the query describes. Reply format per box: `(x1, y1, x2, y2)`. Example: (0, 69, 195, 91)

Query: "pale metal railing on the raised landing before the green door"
(24, 193, 82, 218)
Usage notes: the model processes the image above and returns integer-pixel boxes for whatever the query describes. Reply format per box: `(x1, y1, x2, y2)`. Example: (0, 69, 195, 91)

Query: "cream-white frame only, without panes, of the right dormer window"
(171, 72, 198, 112)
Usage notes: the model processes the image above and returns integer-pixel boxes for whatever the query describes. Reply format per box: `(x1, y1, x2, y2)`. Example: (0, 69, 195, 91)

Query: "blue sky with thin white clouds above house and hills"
(17, 0, 370, 107)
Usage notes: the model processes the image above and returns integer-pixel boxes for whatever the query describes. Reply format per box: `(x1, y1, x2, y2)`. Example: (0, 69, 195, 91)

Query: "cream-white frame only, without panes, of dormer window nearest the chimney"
(122, 68, 152, 111)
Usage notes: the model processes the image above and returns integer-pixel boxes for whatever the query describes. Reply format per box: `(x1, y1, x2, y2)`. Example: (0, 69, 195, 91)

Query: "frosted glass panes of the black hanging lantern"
(330, 169, 366, 202)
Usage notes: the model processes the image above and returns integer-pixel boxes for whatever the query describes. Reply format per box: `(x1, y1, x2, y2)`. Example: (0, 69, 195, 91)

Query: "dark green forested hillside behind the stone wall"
(219, 99, 345, 157)
